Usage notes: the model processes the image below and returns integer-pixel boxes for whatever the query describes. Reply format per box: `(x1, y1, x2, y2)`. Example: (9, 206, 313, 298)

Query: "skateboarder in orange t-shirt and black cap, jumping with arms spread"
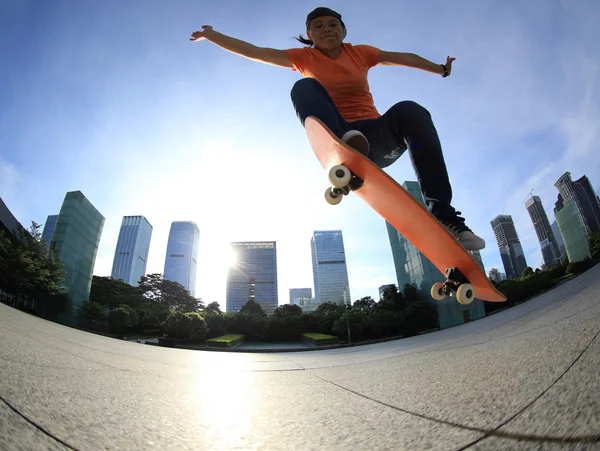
(190, 7, 485, 250)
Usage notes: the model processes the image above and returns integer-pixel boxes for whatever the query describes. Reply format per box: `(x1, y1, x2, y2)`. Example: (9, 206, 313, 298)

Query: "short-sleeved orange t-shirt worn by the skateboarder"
(287, 43, 380, 122)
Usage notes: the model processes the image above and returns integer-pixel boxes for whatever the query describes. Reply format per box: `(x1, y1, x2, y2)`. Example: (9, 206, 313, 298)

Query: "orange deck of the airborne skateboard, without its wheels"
(304, 116, 506, 302)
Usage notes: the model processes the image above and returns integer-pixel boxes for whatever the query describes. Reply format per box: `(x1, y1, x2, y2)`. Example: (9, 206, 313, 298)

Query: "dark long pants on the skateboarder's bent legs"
(292, 78, 454, 210)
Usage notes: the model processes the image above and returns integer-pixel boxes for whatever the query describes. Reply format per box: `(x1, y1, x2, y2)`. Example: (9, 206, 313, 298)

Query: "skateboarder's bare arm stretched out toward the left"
(190, 25, 292, 68)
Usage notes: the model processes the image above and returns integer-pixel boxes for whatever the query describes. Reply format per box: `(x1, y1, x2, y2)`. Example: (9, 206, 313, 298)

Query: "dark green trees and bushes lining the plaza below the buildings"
(0, 222, 600, 343)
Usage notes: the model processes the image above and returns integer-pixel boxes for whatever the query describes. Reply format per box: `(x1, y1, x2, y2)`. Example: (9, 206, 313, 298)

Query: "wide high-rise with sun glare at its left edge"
(225, 241, 279, 315)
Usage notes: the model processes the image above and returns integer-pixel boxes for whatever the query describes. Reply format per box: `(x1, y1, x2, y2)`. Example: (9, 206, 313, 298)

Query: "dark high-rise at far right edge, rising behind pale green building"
(554, 172, 600, 236)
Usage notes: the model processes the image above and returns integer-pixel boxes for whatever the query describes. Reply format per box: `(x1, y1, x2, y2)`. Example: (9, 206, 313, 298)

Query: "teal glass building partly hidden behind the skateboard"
(385, 181, 485, 329)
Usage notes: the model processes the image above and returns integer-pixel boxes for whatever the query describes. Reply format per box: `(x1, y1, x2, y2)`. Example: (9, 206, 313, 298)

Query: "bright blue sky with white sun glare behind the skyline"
(0, 0, 600, 304)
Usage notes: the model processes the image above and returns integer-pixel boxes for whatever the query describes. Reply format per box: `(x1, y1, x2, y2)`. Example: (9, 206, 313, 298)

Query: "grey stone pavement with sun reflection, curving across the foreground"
(0, 265, 600, 450)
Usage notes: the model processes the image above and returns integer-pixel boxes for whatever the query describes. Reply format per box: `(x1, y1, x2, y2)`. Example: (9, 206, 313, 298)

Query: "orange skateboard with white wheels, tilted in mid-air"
(304, 116, 506, 304)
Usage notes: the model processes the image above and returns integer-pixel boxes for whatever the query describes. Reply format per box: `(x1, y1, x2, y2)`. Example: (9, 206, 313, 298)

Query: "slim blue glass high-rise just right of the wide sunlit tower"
(310, 230, 352, 305)
